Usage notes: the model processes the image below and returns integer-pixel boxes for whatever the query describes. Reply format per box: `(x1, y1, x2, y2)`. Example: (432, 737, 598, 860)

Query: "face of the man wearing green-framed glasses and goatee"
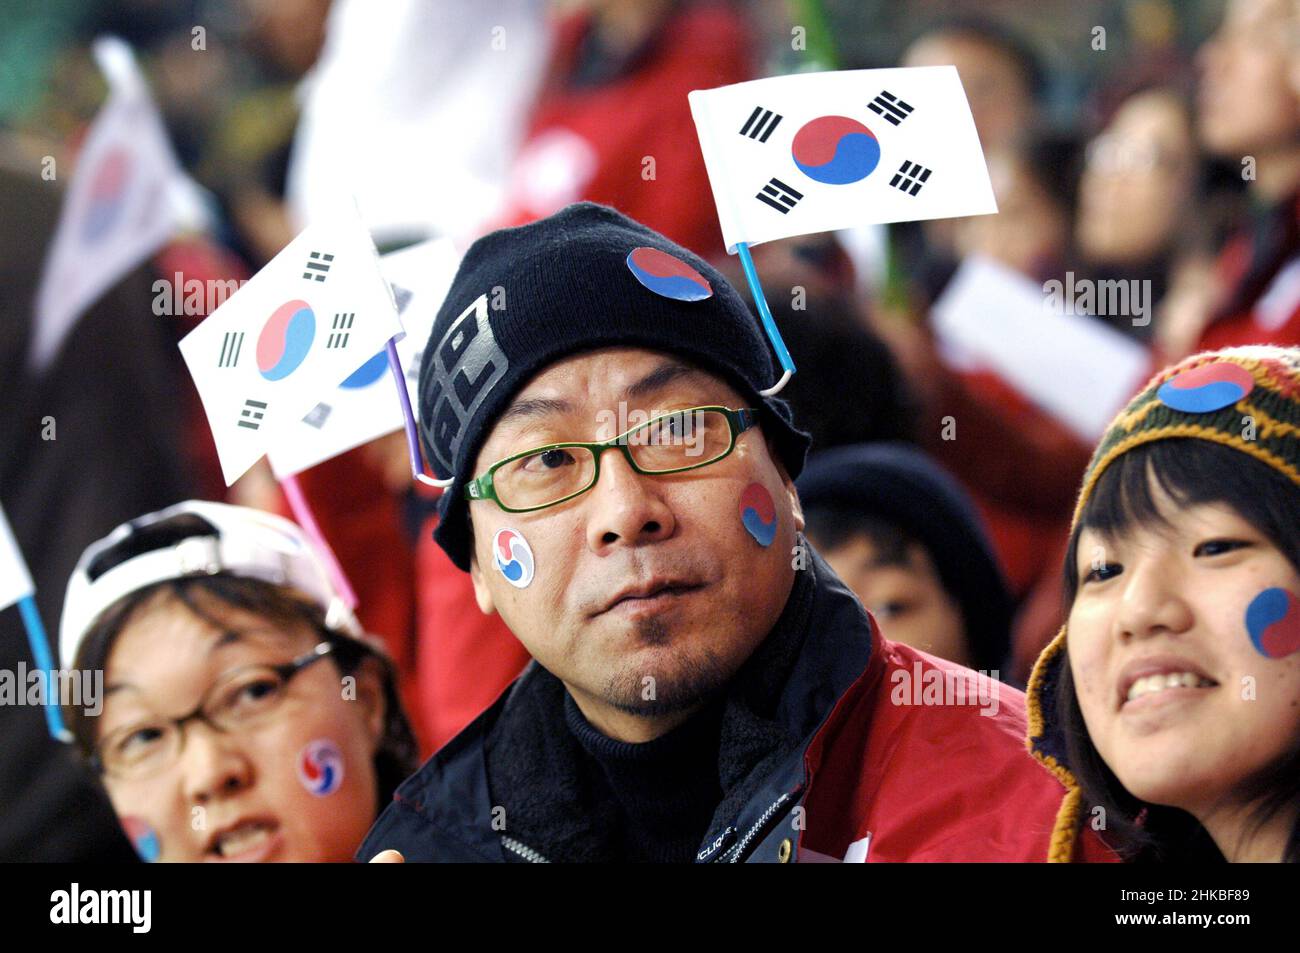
(460, 347, 803, 733)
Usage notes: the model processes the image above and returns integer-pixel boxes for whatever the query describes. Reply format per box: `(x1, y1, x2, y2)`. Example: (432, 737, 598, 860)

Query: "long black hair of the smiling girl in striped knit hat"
(1056, 438, 1300, 863)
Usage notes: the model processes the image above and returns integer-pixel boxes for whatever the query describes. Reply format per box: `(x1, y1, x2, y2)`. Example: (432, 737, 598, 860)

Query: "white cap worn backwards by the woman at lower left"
(59, 501, 363, 667)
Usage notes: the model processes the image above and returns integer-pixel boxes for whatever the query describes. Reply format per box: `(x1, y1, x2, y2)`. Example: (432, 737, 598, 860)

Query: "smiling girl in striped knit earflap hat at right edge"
(1028, 346, 1300, 862)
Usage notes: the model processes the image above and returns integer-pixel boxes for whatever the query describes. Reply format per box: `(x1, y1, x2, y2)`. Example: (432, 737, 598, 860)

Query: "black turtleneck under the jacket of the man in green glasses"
(564, 692, 723, 863)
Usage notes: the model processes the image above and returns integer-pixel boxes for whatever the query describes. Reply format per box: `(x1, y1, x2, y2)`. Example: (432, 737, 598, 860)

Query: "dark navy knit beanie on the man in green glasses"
(420, 203, 809, 571)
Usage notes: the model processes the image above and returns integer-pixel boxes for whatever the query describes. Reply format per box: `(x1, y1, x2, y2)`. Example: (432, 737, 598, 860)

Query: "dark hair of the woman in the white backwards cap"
(66, 514, 419, 813)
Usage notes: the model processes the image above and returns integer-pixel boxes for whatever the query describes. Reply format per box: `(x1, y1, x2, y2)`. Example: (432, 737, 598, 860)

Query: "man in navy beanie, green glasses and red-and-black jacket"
(358, 204, 1109, 863)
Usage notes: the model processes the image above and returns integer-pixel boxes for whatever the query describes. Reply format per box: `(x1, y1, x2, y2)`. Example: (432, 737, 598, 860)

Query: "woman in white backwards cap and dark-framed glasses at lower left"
(59, 502, 416, 861)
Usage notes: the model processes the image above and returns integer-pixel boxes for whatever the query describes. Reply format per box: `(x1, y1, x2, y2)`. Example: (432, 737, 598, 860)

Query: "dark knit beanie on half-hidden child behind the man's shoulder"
(797, 443, 1014, 670)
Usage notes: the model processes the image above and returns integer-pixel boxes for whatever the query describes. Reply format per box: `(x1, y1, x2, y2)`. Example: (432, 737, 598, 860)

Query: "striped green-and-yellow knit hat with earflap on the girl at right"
(1026, 345, 1300, 861)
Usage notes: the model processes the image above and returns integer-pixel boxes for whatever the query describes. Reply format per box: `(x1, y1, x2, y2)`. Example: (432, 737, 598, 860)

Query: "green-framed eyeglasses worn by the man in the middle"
(465, 406, 758, 512)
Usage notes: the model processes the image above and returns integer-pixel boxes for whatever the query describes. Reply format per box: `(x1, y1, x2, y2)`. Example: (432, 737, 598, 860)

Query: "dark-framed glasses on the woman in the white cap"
(91, 642, 334, 780)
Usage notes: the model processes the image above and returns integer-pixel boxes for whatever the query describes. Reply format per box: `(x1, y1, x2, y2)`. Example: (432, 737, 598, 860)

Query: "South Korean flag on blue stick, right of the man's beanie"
(689, 66, 997, 252)
